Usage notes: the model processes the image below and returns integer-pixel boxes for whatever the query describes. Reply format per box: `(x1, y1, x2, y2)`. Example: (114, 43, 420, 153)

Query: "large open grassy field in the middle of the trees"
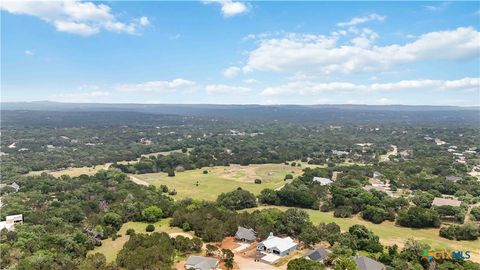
(130, 164, 303, 201)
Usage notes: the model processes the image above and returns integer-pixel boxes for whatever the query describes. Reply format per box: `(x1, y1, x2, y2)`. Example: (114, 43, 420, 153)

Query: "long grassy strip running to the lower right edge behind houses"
(247, 206, 480, 262)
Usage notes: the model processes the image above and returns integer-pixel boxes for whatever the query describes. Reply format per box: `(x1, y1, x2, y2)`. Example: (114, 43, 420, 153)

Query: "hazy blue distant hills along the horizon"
(1, 101, 480, 127)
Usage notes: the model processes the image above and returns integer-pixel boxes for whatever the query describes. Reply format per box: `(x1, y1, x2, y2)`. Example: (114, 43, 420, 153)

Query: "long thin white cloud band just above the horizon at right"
(262, 78, 480, 96)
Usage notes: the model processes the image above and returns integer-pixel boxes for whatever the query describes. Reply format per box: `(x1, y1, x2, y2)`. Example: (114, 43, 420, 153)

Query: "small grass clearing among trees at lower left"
(88, 218, 188, 262)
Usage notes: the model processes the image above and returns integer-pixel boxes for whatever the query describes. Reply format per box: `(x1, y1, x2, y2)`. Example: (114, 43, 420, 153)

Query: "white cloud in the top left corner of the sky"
(0, 0, 150, 36)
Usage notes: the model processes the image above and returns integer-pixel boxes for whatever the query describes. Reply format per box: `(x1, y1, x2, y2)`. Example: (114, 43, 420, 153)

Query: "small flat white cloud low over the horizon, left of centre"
(116, 78, 196, 93)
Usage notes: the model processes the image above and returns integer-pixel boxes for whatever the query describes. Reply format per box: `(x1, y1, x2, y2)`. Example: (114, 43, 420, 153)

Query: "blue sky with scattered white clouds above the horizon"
(0, 0, 480, 106)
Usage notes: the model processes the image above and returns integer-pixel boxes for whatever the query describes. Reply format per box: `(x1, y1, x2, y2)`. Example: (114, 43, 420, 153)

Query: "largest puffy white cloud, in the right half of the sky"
(243, 27, 480, 75)
